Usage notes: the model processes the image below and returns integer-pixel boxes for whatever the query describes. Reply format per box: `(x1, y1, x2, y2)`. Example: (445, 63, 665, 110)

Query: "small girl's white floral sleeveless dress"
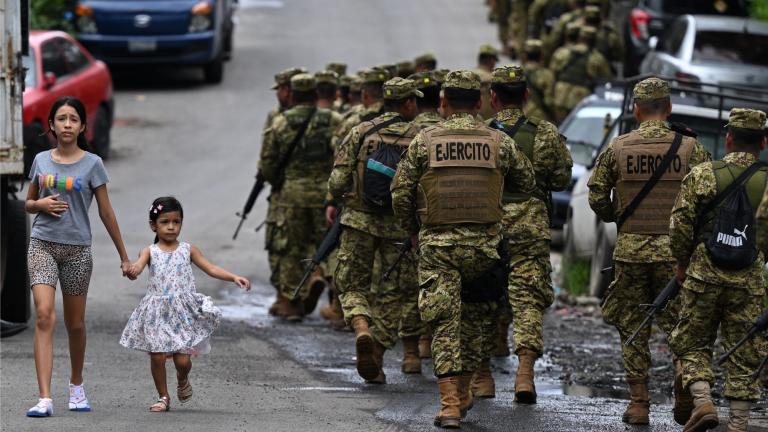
(120, 242, 221, 354)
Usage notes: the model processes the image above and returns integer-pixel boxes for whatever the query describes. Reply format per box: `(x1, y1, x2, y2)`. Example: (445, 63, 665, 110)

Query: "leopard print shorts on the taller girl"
(27, 238, 93, 296)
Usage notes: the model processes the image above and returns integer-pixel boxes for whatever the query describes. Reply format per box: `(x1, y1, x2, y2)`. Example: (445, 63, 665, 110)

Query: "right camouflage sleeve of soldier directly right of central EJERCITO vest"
(532, 121, 573, 191)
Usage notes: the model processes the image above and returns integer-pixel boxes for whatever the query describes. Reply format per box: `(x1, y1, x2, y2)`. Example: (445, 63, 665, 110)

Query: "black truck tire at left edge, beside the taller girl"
(0, 200, 32, 323)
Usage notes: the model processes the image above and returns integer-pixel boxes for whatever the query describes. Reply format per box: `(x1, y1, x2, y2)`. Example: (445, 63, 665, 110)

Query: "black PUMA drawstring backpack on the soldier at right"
(704, 162, 765, 270)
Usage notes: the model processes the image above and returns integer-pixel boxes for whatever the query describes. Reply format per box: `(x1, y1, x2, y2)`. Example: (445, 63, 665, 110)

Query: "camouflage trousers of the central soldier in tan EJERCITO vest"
(419, 246, 495, 377)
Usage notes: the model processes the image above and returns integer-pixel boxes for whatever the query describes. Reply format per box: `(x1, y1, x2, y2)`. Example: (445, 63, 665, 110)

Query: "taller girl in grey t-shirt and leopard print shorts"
(25, 97, 131, 417)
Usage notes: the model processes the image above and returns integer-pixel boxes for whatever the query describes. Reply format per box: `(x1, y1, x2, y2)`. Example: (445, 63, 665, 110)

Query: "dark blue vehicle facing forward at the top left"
(75, 0, 235, 83)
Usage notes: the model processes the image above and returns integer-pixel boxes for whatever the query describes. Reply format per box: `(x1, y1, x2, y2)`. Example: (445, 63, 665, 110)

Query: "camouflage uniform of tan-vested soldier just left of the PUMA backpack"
(588, 78, 709, 379)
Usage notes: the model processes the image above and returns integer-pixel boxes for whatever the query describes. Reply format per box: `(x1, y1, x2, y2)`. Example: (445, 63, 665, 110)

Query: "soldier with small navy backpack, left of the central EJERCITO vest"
(326, 77, 422, 384)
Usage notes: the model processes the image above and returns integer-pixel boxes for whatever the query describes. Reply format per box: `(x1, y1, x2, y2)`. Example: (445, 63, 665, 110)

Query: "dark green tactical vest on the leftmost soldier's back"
(285, 109, 333, 178)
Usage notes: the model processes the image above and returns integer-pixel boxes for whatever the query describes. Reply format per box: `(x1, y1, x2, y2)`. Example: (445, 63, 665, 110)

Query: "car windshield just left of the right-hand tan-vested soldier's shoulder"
(560, 106, 621, 166)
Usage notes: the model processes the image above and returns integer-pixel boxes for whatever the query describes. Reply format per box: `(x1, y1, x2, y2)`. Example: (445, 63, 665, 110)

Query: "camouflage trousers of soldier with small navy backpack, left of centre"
(334, 226, 417, 348)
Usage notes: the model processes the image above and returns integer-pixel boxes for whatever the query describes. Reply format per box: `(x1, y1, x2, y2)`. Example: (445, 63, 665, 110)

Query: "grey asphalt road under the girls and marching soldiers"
(0, 0, 768, 432)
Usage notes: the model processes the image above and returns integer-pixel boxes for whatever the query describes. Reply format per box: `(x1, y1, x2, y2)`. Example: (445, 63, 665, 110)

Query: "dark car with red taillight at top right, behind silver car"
(624, 0, 749, 77)
